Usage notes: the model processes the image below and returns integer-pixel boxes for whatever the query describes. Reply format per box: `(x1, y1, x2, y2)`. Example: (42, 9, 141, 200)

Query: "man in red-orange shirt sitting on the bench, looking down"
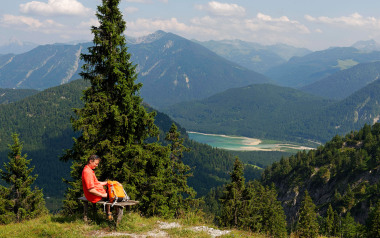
(82, 155, 113, 220)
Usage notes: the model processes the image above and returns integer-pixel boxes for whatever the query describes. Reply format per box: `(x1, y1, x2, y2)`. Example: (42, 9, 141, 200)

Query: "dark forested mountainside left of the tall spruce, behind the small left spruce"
(0, 81, 86, 197)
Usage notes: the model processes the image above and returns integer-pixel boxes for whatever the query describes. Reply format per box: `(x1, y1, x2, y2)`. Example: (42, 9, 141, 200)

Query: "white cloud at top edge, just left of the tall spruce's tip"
(20, 0, 92, 16)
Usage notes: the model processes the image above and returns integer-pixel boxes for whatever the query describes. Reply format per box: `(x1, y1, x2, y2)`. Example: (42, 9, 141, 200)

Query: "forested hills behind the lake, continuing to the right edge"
(164, 80, 380, 143)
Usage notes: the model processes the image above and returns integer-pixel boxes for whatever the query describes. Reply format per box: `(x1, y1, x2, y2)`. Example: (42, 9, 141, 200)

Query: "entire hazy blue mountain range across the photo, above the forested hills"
(0, 31, 380, 108)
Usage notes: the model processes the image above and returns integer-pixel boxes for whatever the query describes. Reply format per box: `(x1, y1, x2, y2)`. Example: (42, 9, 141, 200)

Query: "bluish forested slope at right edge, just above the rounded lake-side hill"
(301, 62, 380, 100)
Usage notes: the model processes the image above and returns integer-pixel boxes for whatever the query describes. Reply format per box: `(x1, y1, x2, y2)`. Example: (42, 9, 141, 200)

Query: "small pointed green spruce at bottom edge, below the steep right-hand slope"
(296, 190, 318, 237)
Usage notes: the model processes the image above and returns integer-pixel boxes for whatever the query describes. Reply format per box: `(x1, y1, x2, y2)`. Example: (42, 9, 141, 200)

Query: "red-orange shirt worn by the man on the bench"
(82, 165, 106, 203)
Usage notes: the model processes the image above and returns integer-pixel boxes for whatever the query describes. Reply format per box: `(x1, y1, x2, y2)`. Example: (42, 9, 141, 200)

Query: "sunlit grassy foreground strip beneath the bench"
(0, 212, 280, 238)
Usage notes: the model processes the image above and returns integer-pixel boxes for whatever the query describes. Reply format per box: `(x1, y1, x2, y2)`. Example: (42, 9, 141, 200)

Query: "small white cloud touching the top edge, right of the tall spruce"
(195, 1, 245, 17)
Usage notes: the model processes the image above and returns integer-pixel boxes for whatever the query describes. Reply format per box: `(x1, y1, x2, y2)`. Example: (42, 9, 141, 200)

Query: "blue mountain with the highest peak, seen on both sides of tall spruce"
(0, 31, 269, 108)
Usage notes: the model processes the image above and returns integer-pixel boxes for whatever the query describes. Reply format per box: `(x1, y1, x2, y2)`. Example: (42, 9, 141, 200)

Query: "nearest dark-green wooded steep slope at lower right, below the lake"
(262, 123, 380, 223)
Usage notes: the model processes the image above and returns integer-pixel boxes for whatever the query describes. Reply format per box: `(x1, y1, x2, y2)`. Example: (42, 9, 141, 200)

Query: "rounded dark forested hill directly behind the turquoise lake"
(165, 84, 333, 141)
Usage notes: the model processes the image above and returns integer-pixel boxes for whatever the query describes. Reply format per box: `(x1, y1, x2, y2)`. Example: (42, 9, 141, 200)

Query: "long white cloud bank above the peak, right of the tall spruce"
(126, 13, 311, 45)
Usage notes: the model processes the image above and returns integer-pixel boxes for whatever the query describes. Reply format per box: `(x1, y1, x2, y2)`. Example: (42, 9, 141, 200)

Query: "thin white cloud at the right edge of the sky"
(305, 13, 380, 29)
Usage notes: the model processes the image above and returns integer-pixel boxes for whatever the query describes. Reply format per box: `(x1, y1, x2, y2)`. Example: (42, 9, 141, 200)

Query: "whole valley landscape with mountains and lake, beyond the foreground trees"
(0, 28, 380, 235)
